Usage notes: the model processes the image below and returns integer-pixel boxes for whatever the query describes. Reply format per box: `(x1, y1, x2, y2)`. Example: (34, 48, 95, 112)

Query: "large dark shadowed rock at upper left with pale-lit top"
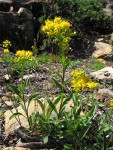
(0, 8, 34, 49)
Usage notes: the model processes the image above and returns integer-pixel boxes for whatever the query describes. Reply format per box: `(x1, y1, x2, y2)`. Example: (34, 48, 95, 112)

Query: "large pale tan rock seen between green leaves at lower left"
(4, 98, 83, 137)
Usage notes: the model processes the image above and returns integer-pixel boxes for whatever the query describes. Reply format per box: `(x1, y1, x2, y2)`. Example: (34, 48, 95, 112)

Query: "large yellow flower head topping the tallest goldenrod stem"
(41, 17, 76, 50)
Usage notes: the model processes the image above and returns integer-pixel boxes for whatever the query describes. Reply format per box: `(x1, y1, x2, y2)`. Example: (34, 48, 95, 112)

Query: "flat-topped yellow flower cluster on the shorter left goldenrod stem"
(15, 50, 33, 62)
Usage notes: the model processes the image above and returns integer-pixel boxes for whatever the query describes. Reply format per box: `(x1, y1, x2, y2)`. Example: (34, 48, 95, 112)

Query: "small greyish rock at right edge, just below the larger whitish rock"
(97, 88, 113, 98)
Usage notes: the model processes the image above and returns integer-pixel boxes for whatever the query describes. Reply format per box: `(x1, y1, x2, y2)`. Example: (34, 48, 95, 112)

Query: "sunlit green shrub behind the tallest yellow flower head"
(40, 0, 112, 29)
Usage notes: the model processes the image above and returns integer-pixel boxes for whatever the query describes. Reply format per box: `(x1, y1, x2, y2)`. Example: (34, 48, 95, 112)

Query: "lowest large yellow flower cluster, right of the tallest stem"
(71, 70, 99, 91)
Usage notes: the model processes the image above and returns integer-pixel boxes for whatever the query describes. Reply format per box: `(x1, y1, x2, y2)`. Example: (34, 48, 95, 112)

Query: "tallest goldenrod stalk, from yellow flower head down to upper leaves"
(41, 16, 76, 92)
